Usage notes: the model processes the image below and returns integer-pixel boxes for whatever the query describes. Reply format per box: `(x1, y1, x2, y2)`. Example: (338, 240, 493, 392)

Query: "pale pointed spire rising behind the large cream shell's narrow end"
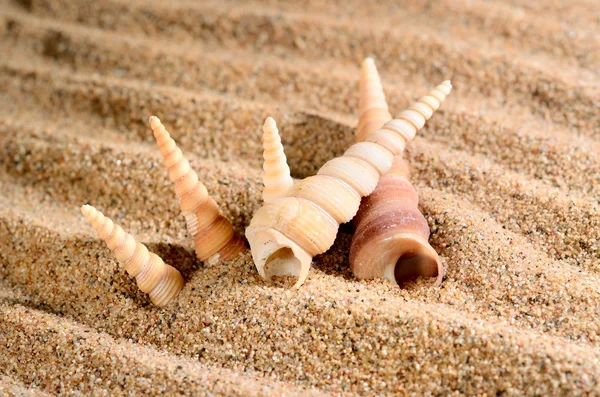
(356, 57, 392, 142)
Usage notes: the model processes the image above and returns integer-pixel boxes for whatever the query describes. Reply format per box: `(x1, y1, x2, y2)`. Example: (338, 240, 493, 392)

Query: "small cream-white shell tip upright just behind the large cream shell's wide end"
(263, 117, 294, 203)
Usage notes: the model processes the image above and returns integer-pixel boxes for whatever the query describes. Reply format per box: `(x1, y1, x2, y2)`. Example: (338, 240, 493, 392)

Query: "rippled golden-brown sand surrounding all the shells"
(0, 0, 600, 395)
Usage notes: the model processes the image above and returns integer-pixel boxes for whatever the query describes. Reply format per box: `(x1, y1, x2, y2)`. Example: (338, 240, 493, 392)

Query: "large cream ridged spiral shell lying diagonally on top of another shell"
(246, 81, 452, 288)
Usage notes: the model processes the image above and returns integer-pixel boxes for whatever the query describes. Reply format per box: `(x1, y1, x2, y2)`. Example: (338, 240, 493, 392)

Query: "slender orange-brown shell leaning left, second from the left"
(150, 116, 245, 263)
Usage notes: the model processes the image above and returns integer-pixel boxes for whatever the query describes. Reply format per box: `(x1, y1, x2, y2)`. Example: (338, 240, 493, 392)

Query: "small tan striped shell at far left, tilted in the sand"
(81, 204, 184, 307)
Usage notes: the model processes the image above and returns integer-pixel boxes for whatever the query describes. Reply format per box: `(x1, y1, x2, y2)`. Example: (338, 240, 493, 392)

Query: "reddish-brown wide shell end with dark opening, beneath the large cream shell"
(350, 156, 445, 285)
